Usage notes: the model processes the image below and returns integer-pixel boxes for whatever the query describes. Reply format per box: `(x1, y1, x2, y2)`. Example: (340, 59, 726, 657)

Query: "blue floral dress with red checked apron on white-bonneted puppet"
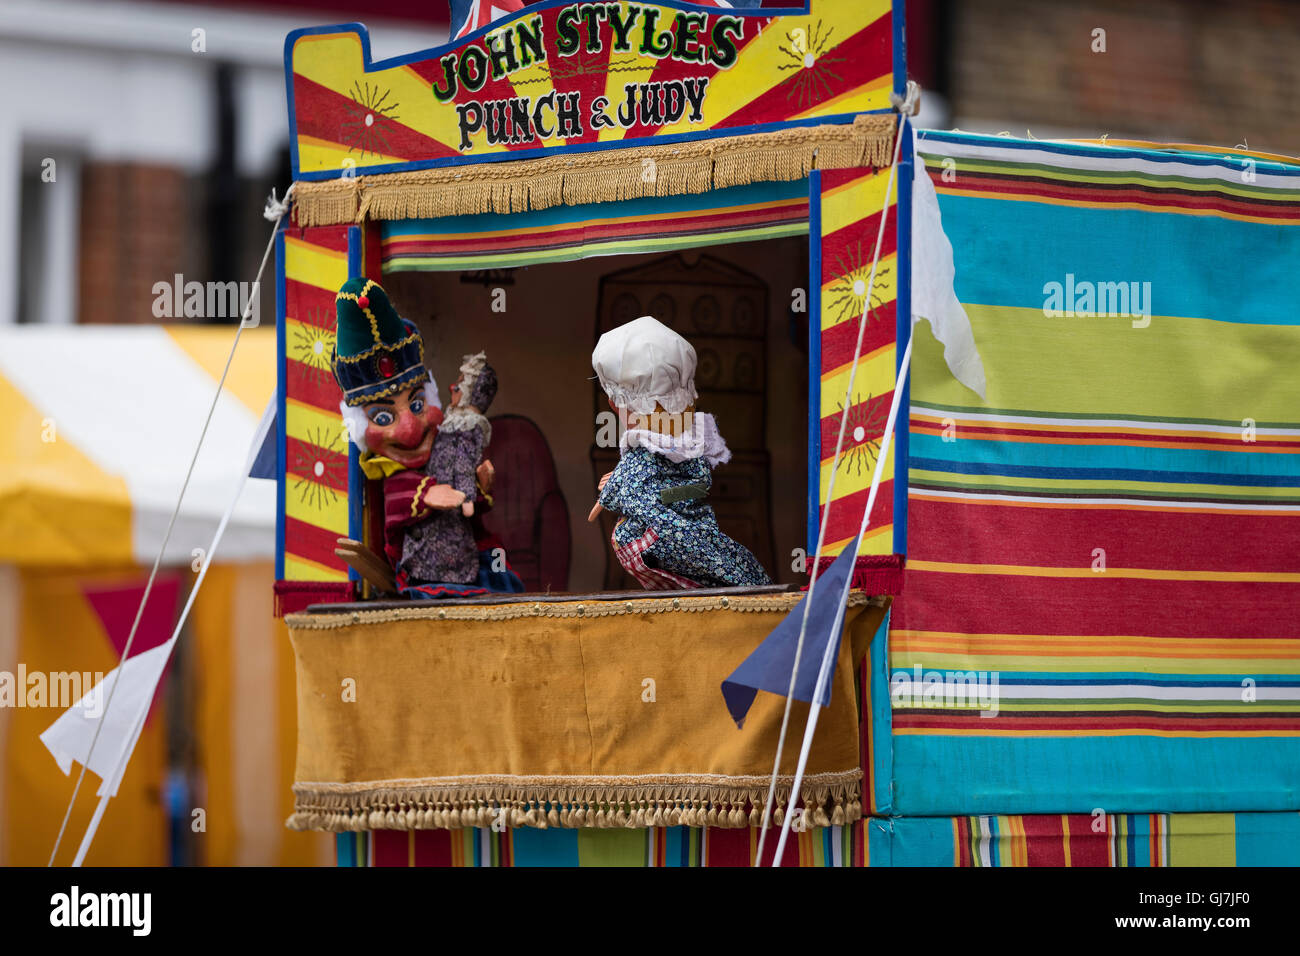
(599, 446, 772, 591)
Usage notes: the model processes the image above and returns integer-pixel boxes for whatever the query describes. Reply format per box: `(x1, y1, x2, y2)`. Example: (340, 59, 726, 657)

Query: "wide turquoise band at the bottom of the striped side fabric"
(894, 735, 1300, 816)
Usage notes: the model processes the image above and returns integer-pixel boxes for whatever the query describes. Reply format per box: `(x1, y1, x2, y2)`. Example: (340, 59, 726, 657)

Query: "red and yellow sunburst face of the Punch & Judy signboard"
(287, 0, 893, 173)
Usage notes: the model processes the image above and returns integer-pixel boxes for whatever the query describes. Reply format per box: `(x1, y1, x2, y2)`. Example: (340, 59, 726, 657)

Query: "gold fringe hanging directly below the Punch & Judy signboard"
(294, 113, 898, 226)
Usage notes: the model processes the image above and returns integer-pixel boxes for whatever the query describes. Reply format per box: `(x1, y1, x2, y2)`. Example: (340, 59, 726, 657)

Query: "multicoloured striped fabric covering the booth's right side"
(889, 133, 1300, 816)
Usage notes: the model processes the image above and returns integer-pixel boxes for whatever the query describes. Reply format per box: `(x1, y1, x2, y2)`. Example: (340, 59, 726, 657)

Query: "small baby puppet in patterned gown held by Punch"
(402, 352, 497, 584)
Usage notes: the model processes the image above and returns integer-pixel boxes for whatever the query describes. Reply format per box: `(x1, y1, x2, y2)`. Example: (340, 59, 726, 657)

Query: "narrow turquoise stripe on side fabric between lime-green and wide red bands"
(911, 434, 1300, 485)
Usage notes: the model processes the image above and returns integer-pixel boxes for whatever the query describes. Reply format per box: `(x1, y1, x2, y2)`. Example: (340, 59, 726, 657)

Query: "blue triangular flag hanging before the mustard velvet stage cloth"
(723, 538, 858, 727)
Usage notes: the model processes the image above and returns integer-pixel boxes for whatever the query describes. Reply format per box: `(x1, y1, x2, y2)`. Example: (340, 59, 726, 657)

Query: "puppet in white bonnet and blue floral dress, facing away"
(588, 316, 772, 591)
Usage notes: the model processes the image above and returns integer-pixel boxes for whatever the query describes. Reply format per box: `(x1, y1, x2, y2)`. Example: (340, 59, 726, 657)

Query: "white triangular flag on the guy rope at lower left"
(40, 636, 176, 796)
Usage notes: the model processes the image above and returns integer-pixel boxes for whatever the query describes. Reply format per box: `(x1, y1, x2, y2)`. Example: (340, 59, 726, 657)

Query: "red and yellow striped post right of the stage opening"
(819, 160, 898, 555)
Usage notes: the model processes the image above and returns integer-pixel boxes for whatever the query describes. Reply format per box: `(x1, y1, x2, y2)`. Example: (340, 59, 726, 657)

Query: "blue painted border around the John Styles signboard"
(285, 0, 906, 182)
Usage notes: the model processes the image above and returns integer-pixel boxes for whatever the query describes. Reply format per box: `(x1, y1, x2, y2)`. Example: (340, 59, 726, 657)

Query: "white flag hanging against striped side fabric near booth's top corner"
(911, 135, 987, 398)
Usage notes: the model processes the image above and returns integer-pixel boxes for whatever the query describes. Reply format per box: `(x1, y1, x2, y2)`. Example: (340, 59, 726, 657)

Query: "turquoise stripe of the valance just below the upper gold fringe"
(380, 179, 809, 239)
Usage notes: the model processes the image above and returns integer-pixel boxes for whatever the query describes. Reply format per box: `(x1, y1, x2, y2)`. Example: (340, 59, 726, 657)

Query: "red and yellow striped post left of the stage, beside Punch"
(282, 226, 348, 581)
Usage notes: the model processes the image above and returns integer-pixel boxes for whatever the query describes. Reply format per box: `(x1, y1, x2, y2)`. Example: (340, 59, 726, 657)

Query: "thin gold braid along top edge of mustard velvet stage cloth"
(285, 591, 889, 631)
